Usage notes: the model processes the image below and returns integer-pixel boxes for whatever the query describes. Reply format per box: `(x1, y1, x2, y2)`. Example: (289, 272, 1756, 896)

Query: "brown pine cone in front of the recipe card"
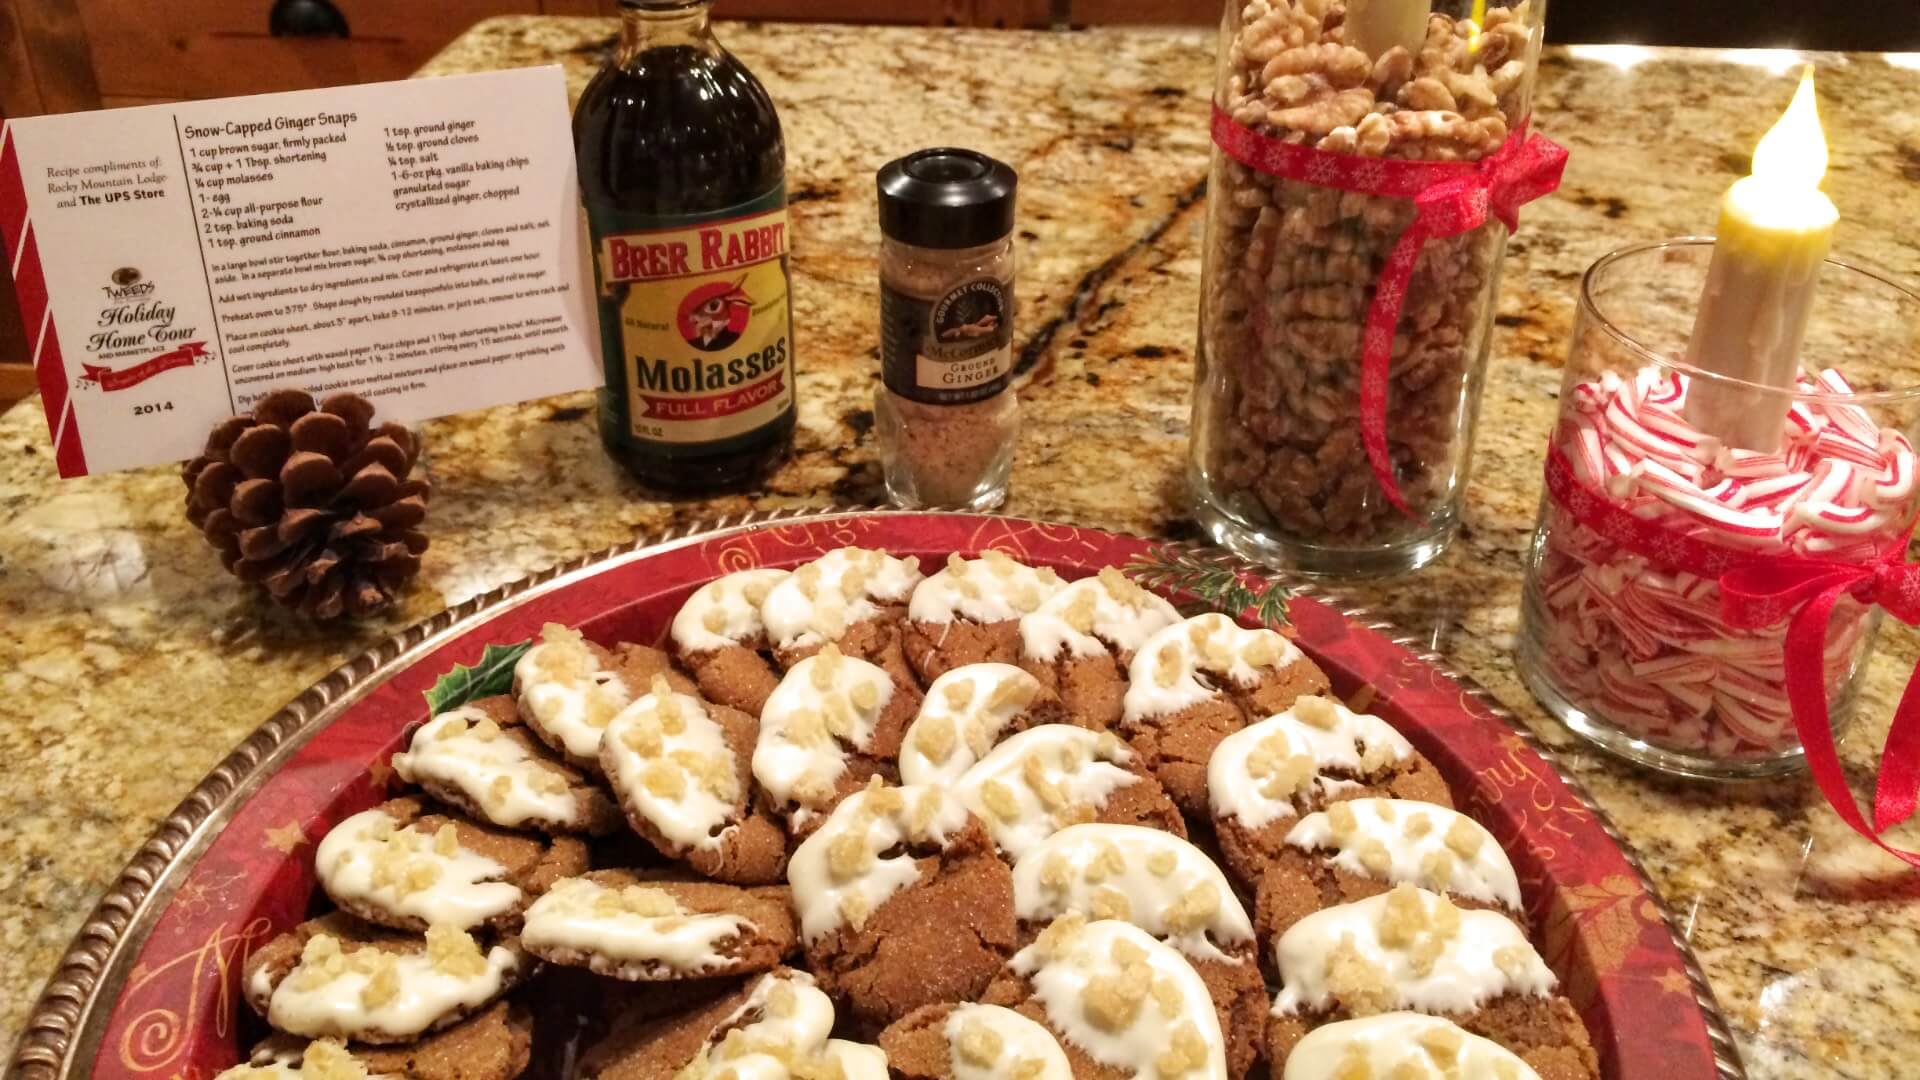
(180, 390, 428, 619)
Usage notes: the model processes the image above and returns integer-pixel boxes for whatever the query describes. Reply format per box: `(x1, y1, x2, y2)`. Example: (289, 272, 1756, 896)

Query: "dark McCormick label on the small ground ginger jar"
(879, 277, 1014, 405)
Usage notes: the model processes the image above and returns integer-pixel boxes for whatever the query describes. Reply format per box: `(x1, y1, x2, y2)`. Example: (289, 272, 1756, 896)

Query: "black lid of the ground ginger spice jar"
(879, 146, 1020, 250)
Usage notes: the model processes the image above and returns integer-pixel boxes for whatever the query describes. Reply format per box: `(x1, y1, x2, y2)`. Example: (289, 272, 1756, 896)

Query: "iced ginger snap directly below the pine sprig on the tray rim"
(1117, 613, 1327, 817)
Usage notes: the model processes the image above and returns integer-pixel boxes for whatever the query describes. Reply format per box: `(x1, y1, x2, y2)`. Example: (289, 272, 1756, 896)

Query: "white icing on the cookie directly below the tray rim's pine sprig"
(1121, 611, 1300, 723)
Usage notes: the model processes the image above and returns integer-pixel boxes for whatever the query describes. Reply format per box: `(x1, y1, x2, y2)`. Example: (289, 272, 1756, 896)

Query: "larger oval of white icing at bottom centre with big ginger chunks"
(1008, 919, 1227, 1080)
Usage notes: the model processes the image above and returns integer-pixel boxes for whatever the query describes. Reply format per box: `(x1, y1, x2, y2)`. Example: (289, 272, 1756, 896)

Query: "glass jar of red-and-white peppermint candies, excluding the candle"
(1517, 238, 1920, 778)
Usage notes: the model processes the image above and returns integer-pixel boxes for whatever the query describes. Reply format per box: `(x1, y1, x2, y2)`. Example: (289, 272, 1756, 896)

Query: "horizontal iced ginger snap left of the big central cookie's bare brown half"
(520, 871, 795, 982)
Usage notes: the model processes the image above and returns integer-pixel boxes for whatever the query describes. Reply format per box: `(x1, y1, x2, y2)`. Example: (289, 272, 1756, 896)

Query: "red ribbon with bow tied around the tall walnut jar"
(1213, 106, 1567, 513)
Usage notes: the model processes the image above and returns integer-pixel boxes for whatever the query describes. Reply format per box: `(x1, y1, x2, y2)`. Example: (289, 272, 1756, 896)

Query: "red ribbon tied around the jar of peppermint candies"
(1548, 446, 1920, 867)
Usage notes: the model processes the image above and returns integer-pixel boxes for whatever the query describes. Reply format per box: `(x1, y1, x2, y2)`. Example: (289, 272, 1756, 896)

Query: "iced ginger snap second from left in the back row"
(760, 548, 922, 686)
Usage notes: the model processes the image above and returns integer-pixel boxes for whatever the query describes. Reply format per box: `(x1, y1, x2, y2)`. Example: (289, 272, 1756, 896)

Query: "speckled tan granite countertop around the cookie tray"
(0, 17, 1920, 1076)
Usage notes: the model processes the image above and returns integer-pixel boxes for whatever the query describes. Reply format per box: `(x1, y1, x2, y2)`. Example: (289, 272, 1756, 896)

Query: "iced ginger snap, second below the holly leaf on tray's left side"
(313, 798, 588, 930)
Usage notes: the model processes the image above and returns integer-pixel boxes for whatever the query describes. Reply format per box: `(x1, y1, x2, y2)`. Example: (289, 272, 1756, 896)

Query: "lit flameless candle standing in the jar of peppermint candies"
(1686, 65, 1839, 454)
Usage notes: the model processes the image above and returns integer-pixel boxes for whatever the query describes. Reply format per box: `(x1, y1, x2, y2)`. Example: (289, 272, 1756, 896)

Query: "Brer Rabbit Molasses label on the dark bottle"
(588, 190, 793, 454)
